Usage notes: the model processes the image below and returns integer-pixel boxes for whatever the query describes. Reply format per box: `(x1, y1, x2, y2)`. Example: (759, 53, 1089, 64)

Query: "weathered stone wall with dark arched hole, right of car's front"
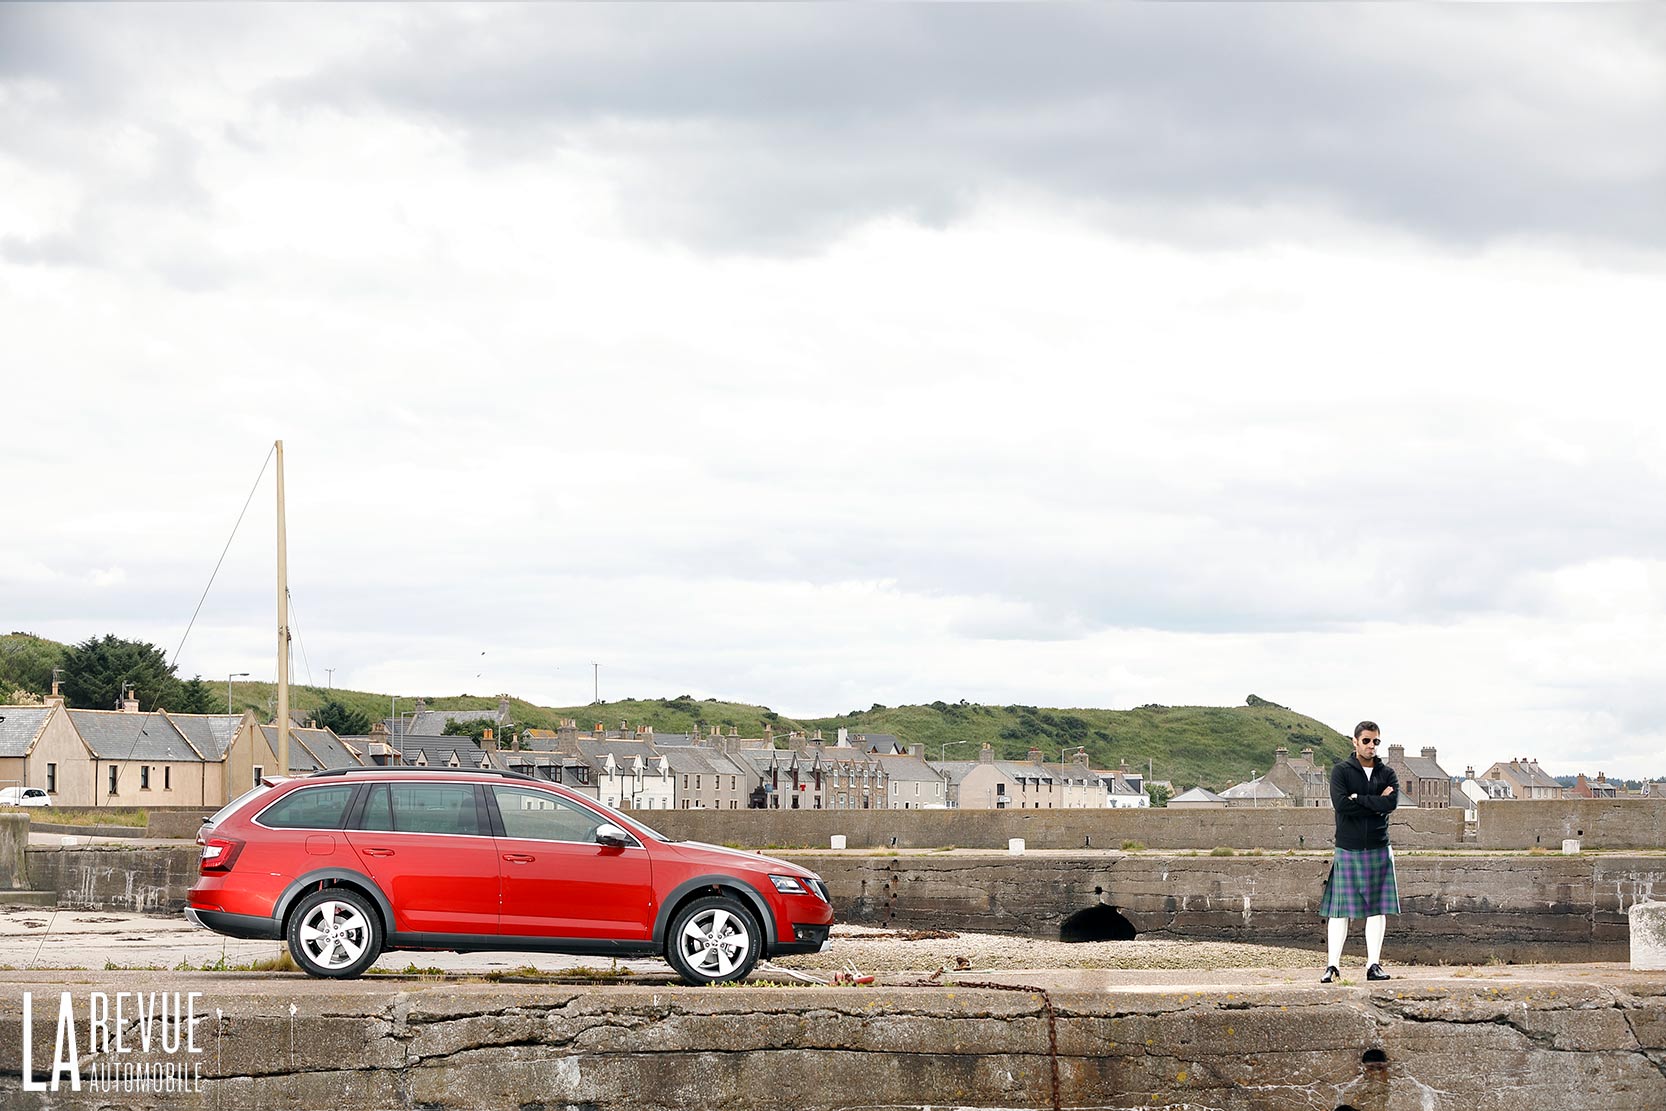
(813, 853, 1666, 963)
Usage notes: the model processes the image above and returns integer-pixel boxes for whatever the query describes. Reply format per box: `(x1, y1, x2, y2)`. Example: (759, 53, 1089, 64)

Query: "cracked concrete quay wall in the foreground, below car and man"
(0, 971, 1666, 1111)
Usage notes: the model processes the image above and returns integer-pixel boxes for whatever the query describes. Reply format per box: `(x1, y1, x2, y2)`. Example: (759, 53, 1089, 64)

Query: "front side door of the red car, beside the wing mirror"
(486, 785, 656, 941)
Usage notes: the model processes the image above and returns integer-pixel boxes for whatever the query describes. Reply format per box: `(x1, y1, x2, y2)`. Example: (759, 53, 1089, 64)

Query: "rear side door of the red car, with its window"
(347, 781, 498, 934)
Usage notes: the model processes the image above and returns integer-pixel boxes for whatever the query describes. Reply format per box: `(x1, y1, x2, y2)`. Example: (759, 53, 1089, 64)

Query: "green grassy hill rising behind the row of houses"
(0, 635, 1348, 790)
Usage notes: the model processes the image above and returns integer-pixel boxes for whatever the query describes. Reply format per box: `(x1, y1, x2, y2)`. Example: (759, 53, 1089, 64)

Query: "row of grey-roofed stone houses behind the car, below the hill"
(0, 693, 1150, 810)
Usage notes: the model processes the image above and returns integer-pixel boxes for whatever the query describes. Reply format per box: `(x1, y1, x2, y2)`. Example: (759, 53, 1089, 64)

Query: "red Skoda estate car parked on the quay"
(185, 768, 833, 984)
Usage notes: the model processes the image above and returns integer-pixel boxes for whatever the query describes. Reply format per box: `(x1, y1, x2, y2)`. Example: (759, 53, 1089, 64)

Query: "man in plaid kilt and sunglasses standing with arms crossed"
(1319, 721, 1399, 984)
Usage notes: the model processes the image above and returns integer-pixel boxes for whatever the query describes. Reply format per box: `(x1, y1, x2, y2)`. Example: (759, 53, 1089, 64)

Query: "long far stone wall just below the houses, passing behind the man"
(636, 806, 1466, 849)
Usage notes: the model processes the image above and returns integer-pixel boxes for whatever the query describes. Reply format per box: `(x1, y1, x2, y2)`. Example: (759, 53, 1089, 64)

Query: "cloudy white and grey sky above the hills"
(0, 5, 1666, 776)
